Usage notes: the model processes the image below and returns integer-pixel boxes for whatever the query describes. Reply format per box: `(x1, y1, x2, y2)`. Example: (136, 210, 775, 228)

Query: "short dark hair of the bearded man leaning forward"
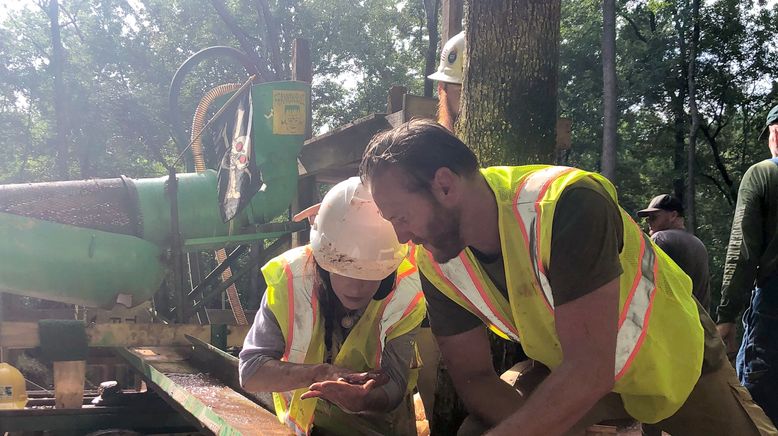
(359, 120, 478, 190)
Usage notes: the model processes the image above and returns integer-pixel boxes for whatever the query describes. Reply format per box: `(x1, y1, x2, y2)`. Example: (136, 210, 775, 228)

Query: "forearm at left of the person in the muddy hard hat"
(243, 360, 329, 392)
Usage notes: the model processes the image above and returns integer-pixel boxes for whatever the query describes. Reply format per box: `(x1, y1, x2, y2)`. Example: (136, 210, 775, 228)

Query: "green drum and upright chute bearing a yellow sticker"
(0, 78, 310, 321)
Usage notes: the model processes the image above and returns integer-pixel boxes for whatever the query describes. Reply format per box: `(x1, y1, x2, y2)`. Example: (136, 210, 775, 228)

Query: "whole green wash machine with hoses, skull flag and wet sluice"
(0, 47, 324, 435)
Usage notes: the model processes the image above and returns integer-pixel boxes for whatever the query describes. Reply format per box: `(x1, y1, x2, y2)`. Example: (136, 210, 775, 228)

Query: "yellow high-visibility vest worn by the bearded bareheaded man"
(416, 165, 704, 423)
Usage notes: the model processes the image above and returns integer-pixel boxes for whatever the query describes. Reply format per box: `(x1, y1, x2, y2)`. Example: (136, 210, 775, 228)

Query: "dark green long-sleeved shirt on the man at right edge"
(718, 160, 778, 323)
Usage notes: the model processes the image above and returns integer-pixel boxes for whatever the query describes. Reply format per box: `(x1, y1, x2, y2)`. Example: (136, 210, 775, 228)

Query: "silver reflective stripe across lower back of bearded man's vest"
(616, 232, 656, 379)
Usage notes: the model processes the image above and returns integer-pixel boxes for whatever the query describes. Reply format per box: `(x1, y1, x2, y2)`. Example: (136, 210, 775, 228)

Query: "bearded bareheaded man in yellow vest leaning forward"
(360, 121, 776, 436)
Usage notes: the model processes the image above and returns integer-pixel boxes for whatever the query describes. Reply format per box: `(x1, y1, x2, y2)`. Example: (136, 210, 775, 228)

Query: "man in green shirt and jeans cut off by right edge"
(718, 106, 778, 422)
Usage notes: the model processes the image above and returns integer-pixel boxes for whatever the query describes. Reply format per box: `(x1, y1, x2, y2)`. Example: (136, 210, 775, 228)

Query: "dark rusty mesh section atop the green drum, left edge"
(0, 178, 139, 236)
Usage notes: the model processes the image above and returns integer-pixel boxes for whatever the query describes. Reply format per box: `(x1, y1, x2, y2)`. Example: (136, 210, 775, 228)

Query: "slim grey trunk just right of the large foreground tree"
(601, 0, 618, 182)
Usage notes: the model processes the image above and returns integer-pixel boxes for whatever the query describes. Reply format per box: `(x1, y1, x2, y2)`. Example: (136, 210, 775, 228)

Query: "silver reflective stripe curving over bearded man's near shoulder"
(513, 166, 574, 308)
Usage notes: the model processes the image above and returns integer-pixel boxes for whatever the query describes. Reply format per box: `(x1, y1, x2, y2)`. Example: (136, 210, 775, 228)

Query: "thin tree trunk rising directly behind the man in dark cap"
(686, 0, 700, 234)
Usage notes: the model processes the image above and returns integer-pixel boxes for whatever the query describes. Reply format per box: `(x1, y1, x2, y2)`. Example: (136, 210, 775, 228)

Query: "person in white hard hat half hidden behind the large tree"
(427, 32, 465, 132)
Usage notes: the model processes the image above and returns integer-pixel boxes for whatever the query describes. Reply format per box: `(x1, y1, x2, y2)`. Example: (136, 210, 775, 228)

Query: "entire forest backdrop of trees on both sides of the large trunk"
(0, 0, 778, 316)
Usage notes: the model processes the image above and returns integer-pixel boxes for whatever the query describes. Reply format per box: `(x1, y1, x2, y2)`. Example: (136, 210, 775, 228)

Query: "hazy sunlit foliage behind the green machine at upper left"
(0, 0, 427, 183)
